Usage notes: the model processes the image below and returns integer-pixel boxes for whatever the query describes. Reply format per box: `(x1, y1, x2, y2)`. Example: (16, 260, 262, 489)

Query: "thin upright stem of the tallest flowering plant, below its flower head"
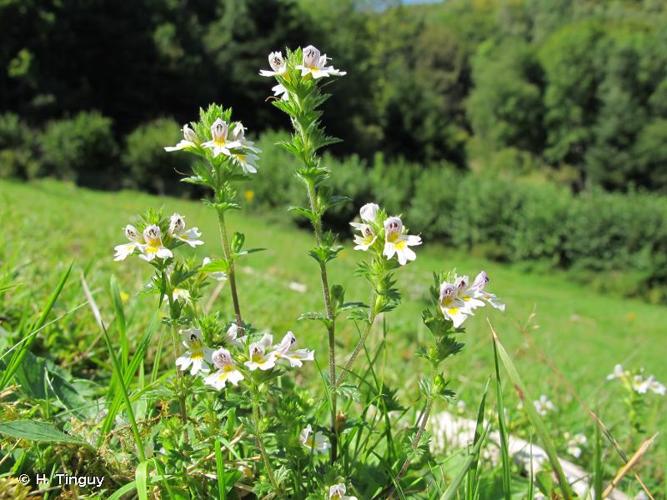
(305, 179, 338, 463)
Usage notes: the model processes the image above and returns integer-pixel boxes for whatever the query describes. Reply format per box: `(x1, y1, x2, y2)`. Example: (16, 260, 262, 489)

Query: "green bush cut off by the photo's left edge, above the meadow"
(0, 113, 40, 179)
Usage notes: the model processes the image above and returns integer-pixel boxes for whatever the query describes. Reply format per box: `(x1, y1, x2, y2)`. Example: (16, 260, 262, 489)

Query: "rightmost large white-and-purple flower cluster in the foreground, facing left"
(440, 271, 505, 328)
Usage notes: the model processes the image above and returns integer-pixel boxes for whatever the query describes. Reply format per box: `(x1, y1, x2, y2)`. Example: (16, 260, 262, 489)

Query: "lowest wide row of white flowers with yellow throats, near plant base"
(176, 323, 314, 390)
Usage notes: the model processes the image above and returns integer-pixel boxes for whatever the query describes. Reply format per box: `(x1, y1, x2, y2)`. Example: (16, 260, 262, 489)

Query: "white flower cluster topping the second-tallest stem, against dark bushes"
(164, 110, 260, 174)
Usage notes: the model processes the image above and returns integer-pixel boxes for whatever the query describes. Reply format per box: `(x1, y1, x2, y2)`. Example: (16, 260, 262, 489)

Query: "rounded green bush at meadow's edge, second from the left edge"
(39, 111, 119, 188)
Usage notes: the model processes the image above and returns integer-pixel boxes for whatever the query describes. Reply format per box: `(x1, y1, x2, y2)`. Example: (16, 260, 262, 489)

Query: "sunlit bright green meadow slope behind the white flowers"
(0, 181, 667, 492)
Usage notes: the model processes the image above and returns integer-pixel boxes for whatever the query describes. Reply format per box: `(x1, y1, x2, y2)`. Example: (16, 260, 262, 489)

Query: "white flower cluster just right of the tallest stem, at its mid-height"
(350, 203, 422, 266)
